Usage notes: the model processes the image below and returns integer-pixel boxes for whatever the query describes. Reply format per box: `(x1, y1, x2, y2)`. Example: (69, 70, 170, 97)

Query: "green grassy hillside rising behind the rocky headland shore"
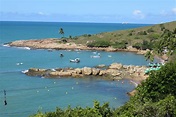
(69, 21, 176, 48)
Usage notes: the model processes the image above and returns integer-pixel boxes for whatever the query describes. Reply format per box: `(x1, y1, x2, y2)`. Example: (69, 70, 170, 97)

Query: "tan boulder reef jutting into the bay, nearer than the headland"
(25, 63, 146, 79)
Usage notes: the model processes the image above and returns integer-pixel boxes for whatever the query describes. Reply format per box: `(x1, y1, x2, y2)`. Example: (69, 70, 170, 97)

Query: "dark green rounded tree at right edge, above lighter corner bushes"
(138, 61, 176, 102)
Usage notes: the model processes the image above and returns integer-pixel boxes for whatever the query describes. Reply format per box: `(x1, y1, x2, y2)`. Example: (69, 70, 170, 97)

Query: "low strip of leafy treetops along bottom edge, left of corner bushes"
(30, 101, 112, 117)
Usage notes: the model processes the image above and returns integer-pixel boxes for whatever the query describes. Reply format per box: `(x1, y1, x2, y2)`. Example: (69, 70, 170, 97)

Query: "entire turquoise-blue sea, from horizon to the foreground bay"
(0, 22, 151, 117)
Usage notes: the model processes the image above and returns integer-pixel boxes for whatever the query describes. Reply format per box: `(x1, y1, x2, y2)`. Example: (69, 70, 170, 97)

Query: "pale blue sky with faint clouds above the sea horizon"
(0, 0, 176, 24)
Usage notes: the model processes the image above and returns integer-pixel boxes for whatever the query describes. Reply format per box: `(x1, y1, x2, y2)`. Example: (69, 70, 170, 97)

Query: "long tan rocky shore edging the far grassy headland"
(4, 38, 147, 55)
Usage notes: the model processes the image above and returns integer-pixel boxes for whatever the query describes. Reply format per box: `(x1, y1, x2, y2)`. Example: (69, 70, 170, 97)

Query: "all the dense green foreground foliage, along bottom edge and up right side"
(31, 60, 176, 117)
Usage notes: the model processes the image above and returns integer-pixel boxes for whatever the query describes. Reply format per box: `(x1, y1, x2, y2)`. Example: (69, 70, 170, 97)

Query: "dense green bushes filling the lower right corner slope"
(115, 61, 176, 117)
